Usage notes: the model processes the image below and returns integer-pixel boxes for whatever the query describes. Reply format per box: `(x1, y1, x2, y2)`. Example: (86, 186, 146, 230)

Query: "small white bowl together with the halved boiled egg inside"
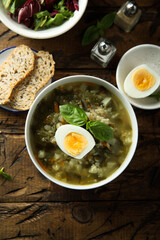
(116, 44, 160, 110)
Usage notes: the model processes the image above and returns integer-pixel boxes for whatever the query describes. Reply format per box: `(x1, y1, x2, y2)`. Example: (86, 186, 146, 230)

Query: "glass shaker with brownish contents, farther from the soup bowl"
(114, 1, 142, 32)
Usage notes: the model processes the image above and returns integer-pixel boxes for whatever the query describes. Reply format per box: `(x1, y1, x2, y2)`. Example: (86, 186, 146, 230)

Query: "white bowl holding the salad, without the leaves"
(0, 0, 88, 39)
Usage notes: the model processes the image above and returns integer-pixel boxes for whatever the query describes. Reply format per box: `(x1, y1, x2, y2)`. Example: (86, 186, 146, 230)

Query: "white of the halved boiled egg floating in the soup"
(55, 124, 95, 159)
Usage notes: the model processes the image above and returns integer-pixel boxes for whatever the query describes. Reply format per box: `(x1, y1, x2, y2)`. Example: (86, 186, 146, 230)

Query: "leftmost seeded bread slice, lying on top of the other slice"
(0, 45, 35, 104)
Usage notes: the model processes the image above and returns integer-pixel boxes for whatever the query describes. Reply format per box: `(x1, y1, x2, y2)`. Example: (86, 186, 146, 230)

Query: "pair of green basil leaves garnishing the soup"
(59, 104, 114, 142)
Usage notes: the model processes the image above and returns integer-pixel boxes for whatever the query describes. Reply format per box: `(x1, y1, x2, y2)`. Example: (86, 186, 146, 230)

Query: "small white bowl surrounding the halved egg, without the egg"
(116, 44, 160, 110)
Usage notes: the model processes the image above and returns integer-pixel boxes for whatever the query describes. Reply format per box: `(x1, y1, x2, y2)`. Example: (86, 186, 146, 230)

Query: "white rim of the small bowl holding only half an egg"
(116, 44, 160, 110)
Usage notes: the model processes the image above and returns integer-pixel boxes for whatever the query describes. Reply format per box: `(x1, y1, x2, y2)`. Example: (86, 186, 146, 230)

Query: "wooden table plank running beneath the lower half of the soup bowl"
(0, 134, 160, 202)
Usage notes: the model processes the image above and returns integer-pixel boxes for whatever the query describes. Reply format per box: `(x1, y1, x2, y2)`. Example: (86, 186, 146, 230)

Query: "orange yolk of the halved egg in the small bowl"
(132, 68, 156, 91)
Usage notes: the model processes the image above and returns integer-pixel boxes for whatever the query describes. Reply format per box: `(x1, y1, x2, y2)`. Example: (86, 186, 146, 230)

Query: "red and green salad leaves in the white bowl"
(2, 0, 79, 30)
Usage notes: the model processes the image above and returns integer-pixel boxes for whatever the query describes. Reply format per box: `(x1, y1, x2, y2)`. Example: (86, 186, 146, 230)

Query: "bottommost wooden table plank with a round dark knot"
(0, 201, 160, 240)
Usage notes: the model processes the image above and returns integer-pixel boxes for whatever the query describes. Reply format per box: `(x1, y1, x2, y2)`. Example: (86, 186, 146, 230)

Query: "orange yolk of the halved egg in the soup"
(64, 132, 88, 156)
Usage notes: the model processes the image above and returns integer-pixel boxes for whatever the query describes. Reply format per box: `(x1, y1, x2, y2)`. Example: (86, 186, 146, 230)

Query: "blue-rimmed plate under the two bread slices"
(0, 46, 53, 113)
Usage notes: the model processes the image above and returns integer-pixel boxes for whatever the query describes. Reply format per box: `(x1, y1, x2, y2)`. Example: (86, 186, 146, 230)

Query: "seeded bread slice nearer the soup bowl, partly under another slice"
(8, 51, 55, 111)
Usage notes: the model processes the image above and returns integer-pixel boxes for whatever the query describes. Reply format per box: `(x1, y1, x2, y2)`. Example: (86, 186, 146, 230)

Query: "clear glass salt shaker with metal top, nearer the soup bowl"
(90, 38, 117, 68)
